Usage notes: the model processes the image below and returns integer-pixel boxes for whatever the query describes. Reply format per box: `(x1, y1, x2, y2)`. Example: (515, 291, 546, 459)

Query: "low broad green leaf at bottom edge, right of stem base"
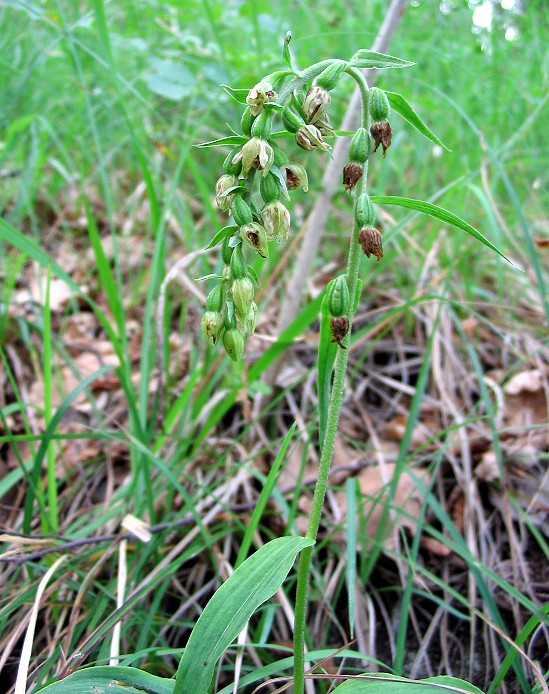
(334, 672, 482, 694)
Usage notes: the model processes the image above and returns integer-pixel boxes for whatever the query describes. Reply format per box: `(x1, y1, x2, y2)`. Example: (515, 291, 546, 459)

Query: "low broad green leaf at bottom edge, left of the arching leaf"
(40, 665, 175, 694)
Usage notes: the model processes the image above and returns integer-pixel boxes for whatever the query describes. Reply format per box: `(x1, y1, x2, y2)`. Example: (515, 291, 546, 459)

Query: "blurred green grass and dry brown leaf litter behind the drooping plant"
(0, 0, 549, 692)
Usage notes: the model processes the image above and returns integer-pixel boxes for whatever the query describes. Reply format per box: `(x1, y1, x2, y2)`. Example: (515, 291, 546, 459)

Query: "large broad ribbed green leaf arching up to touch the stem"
(173, 537, 314, 694)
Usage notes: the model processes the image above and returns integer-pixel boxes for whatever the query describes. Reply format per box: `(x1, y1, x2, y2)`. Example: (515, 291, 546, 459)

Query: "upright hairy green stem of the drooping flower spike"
(294, 68, 370, 694)
